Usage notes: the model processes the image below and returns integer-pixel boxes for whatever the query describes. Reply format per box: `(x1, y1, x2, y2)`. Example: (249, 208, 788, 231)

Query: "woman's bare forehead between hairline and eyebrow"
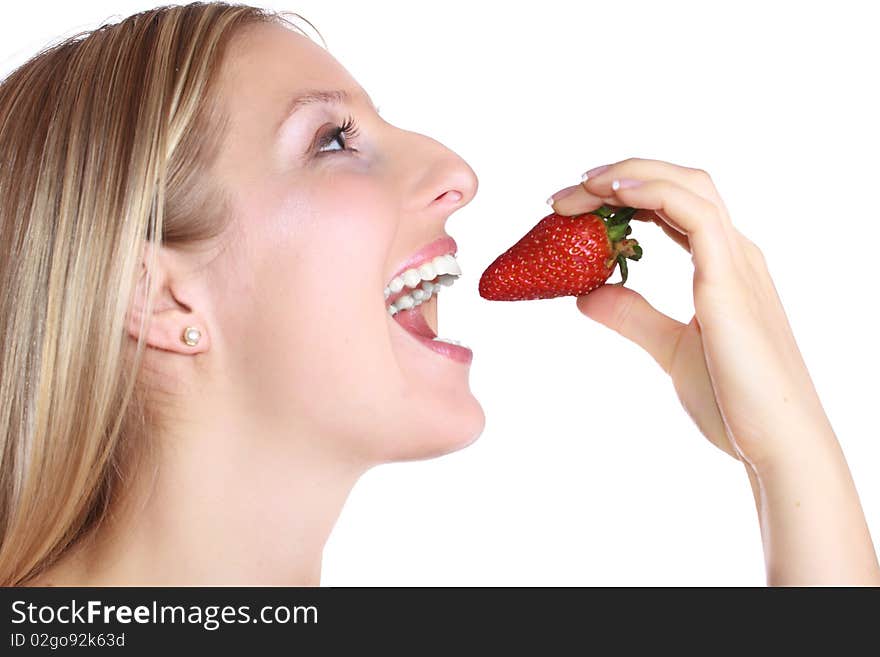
(220, 24, 363, 123)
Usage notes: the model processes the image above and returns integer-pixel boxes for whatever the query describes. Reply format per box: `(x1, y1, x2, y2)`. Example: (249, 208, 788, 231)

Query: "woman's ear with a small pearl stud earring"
(126, 246, 210, 354)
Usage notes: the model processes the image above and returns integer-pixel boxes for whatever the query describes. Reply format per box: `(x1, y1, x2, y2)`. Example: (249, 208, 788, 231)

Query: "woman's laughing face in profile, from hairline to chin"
(206, 25, 485, 464)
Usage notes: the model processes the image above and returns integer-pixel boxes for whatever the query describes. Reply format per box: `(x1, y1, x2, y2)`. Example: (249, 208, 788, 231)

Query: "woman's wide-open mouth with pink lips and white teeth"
(384, 247, 473, 363)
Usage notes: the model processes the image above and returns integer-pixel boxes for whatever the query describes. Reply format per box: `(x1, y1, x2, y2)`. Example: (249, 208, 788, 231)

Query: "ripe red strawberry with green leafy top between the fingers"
(480, 205, 642, 301)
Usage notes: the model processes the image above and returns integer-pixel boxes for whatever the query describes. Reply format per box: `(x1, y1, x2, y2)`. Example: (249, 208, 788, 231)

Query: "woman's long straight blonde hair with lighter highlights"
(0, 3, 320, 586)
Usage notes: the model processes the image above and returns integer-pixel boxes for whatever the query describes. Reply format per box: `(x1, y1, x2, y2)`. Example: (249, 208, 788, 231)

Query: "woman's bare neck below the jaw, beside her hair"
(29, 410, 366, 586)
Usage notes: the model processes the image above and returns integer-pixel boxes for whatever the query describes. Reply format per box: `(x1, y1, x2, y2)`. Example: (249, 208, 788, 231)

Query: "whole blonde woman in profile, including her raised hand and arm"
(0, 4, 880, 585)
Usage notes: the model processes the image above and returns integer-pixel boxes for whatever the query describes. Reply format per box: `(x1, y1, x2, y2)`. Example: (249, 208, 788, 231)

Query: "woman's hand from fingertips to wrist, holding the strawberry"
(553, 158, 825, 467)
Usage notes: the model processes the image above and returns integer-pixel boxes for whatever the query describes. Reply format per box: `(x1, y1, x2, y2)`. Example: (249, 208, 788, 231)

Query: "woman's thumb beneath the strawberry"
(577, 285, 686, 373)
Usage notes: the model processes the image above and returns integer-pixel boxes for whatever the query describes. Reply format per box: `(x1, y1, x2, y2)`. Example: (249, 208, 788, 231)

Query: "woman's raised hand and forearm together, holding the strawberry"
(552, 158, 880, 585)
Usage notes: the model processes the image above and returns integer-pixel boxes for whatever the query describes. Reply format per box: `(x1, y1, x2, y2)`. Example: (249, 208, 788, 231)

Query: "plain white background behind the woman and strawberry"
(0, 0, 880, 585)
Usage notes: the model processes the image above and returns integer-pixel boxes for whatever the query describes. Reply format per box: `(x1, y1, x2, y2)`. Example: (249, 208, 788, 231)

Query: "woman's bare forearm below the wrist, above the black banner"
(745, 418, 880, 586)
